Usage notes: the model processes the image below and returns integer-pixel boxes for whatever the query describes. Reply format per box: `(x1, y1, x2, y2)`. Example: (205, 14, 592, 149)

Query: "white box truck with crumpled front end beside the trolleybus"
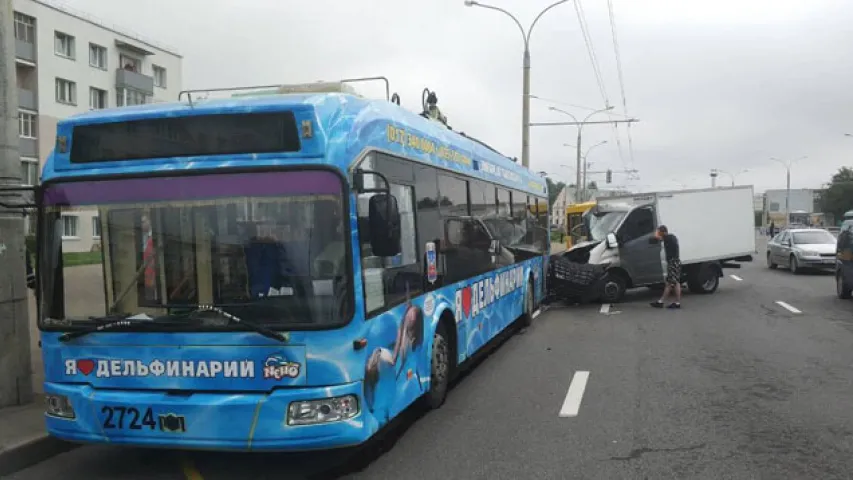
(548, 186, 755, 303)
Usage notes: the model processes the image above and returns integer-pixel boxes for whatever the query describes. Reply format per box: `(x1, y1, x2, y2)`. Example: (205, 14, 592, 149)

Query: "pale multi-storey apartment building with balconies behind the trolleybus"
(14, 0, 183, 252)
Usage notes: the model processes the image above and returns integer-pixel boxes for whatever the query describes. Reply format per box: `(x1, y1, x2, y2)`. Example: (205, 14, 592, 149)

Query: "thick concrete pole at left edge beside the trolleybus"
(0, 0, 33, 407)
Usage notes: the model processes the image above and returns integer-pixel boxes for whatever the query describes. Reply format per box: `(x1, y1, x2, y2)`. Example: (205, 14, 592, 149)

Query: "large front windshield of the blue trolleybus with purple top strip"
(39, 171, 352, 330)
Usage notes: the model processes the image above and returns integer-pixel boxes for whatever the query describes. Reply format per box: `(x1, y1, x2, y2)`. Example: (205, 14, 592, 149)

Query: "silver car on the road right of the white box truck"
(767, 228, 836, 274)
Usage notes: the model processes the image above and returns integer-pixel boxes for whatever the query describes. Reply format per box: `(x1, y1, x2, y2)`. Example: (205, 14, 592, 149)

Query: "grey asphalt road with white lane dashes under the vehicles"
(10, 244, 853, 480)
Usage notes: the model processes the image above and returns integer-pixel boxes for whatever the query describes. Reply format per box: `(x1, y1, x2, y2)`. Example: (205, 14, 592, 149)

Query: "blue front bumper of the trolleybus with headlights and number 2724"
(45, 382, 378, 451)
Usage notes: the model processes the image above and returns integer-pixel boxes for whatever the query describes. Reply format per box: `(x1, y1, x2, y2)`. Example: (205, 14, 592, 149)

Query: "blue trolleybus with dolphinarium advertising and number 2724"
(31, 80, 550, 450)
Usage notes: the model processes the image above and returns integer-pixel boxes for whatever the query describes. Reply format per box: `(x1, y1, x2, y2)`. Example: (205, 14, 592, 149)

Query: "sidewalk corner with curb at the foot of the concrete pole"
(0, 395, 75, 477)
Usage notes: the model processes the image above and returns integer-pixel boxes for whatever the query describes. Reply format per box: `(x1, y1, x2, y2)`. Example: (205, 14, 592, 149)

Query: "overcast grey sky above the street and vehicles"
(71, 0, 853, 195)
